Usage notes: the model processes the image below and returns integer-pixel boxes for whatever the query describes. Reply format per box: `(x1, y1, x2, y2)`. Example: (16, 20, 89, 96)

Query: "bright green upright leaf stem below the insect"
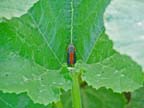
(72, 72, 82, 108)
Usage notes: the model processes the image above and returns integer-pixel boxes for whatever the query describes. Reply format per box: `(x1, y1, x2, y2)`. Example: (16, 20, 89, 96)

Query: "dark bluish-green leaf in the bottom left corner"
(0, 92, 52, 108)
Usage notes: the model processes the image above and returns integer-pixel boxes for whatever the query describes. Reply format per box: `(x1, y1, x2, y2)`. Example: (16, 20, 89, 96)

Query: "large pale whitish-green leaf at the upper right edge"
(104, 0, 144, 69)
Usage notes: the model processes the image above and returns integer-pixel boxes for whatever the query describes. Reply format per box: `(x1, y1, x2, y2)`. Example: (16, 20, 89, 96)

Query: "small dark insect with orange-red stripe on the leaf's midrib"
(67, 44, 76, 66)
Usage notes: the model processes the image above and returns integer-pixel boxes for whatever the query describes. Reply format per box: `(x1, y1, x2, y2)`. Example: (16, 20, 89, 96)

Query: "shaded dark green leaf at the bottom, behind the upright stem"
(62, 87, 126, 108)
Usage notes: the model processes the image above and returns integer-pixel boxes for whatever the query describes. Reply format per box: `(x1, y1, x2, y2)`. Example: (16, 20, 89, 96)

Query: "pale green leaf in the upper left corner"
(0, 0, 38, 19)
